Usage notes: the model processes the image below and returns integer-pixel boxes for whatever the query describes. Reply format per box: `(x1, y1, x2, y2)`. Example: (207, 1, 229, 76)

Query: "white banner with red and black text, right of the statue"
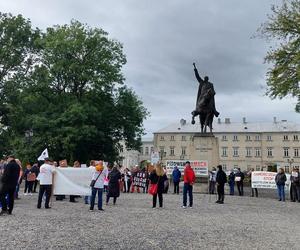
(251, 171, 290, 189)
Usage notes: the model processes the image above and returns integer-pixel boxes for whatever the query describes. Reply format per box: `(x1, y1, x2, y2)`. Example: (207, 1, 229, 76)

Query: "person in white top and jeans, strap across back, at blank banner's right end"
(90, 164, 107, 211)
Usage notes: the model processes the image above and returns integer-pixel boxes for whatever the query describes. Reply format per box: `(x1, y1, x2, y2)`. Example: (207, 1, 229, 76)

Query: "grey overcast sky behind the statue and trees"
(0, 0, 300, 137)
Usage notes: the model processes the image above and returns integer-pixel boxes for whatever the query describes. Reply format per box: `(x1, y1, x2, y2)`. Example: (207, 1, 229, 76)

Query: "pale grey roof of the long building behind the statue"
(154, 120, 300, 134)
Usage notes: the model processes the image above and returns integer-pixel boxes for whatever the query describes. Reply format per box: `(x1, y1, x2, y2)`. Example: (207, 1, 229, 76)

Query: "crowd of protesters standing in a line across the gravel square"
(0, 156, 300, 215)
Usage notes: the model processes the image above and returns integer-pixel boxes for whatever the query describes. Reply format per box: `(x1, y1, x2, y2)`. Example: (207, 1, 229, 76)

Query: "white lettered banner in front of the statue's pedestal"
(166, 160, 208, 176)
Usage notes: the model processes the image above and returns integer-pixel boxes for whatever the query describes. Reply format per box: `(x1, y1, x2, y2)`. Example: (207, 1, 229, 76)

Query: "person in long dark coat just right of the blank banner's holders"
(106, 166, 121, 205)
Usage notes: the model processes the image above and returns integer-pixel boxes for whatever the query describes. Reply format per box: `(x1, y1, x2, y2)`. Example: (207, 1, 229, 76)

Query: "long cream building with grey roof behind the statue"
(154, 118, 300, 171)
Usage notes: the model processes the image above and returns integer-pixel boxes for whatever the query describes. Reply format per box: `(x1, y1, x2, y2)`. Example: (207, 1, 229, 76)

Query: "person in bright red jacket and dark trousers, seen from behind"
(182, 161, 196, 208)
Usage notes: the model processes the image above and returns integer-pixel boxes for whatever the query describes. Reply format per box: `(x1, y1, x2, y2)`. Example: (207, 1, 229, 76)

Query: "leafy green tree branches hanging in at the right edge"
(259, 0, 300, 112)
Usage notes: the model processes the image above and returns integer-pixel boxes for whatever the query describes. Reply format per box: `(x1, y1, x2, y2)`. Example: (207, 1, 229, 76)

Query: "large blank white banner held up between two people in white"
(53, 168, 95, 195)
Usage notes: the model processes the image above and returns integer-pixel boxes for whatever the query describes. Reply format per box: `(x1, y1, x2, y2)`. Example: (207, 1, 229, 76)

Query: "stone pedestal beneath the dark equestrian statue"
(189, 133, 220, 170)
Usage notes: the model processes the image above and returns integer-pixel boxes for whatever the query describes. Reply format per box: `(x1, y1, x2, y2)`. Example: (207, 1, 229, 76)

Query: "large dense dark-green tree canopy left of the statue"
(0, 14, 148, 165)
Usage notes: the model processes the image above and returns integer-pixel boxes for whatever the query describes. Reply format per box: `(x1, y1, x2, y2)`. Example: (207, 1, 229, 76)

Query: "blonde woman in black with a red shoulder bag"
(149, 164, 167, 208)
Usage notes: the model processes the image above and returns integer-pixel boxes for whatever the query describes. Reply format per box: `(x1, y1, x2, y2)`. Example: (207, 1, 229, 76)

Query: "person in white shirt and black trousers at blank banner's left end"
(37, 158, 55, 209)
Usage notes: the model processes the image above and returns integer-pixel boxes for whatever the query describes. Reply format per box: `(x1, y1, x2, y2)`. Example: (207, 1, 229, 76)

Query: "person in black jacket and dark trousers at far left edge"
(0, 156, 20, 215)
